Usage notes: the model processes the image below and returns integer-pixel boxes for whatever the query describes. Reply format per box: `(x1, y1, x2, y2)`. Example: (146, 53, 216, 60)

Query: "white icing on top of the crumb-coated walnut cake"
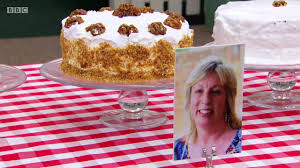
(62, 10, 192, 48)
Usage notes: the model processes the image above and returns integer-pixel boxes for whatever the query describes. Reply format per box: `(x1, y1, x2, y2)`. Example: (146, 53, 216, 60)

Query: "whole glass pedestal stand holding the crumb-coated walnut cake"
(40, 59, 174, 129)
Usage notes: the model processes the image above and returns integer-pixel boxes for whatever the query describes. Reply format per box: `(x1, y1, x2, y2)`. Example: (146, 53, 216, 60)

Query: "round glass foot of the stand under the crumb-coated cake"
(100, 110, 168, 129)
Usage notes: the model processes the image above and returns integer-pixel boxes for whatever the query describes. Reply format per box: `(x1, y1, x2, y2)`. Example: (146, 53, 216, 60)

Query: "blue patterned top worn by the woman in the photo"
(174, 128, 242, 160)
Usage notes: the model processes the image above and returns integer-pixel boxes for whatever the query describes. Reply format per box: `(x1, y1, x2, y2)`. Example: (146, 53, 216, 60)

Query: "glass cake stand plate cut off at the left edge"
(0, 64, 27, 93)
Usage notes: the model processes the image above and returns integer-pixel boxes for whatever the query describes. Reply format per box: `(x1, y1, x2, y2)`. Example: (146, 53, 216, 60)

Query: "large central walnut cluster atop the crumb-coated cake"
(113, 4, 141, 18)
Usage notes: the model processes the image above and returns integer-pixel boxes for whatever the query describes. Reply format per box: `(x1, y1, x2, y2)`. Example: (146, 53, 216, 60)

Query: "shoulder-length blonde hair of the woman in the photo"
(184, 56, 242, 143)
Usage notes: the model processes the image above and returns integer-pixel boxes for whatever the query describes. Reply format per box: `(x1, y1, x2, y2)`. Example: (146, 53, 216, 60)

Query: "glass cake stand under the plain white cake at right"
(245, 64, 300, 110)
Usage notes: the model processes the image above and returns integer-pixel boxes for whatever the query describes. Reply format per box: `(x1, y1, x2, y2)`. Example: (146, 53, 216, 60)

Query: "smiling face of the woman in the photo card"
(190, 72, 227, 126)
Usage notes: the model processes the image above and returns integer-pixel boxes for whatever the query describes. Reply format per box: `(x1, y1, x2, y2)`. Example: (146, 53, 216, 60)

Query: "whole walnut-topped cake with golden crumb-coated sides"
(61, 4, 193, 81)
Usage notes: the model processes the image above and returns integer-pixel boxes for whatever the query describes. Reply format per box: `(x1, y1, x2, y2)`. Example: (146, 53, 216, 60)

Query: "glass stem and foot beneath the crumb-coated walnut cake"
(100, 89, 168, 129)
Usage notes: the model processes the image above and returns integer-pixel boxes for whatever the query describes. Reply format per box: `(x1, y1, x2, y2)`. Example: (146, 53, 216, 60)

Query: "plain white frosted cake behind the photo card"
(212, 0, 300, 65)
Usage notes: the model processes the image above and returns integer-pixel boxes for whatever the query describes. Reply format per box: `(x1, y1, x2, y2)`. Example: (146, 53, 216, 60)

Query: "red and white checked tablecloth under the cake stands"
(0, 64, 300, 168)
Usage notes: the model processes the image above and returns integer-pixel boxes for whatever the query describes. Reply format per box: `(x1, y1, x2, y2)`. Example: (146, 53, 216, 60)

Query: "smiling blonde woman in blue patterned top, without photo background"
(174, 56, 242, 160)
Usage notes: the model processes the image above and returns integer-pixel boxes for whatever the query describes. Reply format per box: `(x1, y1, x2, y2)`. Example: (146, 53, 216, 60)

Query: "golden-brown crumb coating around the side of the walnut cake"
(60, 31, 193, 81)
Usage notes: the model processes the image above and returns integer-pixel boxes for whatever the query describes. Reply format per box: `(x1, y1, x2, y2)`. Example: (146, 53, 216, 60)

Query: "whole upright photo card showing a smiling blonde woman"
(173, 44, 245, 160)
